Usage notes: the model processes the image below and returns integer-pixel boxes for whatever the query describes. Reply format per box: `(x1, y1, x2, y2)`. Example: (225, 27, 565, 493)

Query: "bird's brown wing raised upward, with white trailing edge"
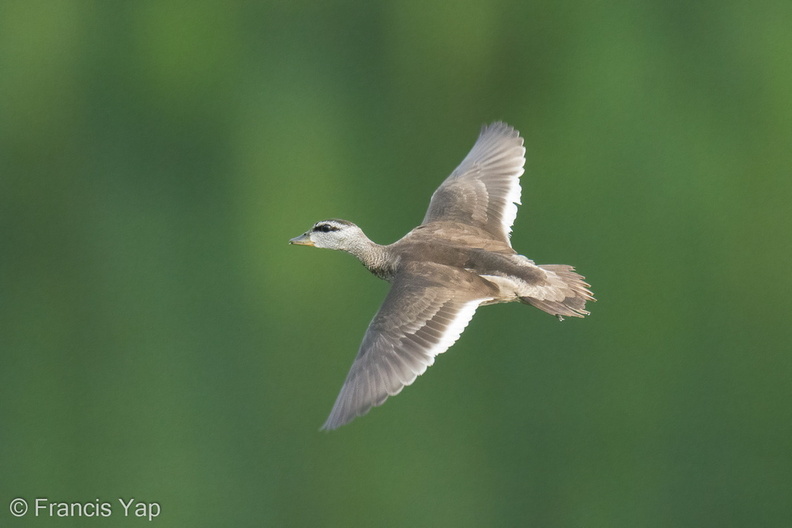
(423, 122, 525, 247)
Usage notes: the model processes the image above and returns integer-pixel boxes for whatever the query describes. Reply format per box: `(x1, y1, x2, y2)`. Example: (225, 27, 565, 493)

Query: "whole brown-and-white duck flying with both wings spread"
(289, 122, 595, 430)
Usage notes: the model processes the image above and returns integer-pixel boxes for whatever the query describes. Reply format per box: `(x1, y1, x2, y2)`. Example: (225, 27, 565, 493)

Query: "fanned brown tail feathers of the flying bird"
(520, 264, 596, 319)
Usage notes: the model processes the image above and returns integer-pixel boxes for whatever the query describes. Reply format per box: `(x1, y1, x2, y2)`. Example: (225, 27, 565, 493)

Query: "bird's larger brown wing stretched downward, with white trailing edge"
(322, 263, 492, 429)
